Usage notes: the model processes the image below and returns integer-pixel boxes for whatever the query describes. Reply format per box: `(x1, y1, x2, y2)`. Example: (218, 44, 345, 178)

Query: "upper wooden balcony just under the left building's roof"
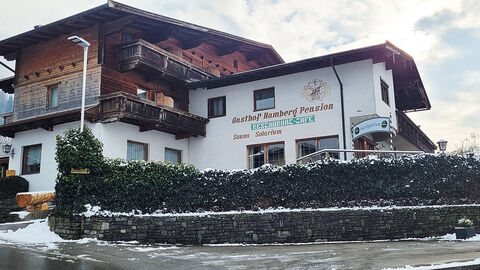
(120, 39, 212, 83)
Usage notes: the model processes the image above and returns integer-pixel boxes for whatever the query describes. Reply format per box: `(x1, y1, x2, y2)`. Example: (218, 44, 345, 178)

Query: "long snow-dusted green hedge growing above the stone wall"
(56, 129, 480, 214)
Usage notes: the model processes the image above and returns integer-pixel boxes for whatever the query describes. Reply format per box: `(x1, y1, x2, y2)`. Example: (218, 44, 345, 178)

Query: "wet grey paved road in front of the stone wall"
(0, 241, 480, 270)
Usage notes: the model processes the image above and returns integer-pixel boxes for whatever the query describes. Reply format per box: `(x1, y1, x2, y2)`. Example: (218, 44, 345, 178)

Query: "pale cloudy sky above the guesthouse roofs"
(0, 0, 480, 150)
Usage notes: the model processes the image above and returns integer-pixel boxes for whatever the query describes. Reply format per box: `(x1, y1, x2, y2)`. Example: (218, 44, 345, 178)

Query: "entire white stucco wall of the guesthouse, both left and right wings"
(9, 60, 404, 191)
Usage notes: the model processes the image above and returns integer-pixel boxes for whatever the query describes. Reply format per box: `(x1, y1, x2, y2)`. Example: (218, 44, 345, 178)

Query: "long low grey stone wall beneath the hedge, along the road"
(49, 205, 480, 245)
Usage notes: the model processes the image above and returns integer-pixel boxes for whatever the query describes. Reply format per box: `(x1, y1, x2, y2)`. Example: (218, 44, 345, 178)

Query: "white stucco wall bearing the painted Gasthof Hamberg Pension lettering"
(189, 60, 394, 169)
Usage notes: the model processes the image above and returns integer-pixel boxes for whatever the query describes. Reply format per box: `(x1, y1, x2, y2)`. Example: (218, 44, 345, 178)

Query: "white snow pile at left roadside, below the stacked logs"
(0, 219, 65, 244)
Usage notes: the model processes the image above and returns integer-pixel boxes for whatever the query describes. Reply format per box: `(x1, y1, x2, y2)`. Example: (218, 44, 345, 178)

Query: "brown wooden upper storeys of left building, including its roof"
(0, 1, 283, 137)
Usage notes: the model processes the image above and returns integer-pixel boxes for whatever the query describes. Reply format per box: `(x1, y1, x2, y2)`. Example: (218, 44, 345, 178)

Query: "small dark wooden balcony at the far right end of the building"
(397, 111, 437, 153)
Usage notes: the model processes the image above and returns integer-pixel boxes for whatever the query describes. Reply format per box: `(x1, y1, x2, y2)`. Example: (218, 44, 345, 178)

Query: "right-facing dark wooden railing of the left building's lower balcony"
(98, 93, 209, 138)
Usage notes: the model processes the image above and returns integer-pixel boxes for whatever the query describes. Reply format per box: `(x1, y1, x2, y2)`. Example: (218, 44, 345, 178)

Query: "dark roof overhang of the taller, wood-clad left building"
(0, 0, 284, 64)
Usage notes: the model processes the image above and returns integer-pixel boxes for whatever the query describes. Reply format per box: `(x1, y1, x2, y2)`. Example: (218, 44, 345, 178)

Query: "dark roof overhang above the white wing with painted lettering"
(187, 41, 431, 111)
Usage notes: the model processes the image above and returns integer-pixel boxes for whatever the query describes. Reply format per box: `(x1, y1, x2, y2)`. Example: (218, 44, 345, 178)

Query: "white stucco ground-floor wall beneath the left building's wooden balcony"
(9, 122, 188, 191)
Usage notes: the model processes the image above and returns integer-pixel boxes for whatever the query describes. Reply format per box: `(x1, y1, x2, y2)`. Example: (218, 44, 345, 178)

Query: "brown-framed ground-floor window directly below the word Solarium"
(247, 142, 285, 169)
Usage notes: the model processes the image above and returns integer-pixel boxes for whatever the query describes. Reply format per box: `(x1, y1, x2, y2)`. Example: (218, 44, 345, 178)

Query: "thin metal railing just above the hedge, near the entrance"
(297, 149, 425, 164)
